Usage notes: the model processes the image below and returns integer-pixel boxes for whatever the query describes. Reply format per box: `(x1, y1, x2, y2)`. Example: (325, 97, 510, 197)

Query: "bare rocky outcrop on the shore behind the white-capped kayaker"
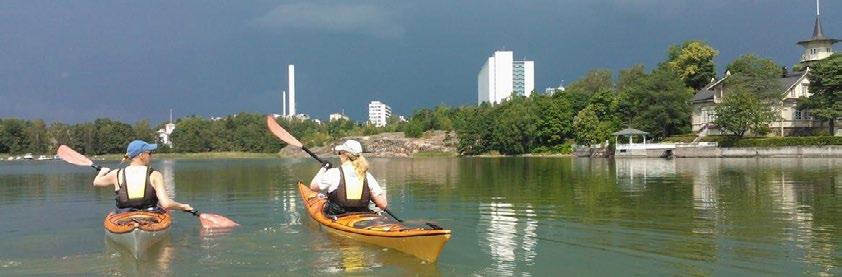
(279, 131, 459, 158)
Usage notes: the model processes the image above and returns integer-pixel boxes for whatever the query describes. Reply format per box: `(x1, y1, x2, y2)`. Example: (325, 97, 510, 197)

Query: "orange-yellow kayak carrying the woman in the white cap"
(298, 182, 450, 263)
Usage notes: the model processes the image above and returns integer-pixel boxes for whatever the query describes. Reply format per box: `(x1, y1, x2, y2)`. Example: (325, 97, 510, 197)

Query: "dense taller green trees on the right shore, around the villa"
(404, 46, 842, 154)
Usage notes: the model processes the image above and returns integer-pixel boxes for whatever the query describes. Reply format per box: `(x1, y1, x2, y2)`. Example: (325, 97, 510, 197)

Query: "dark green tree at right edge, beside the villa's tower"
(798, 54, 842, 134)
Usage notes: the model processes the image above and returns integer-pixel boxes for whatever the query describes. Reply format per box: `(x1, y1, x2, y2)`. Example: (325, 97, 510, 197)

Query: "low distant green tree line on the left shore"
(0, 113, 402, 155)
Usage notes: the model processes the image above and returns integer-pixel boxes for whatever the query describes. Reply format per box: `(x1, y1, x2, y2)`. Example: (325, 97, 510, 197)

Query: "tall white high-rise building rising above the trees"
(477, 51, 535, 104)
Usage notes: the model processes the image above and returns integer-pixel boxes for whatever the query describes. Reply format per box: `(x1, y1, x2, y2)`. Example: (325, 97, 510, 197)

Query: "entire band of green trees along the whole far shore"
(0, 40, 842, 157)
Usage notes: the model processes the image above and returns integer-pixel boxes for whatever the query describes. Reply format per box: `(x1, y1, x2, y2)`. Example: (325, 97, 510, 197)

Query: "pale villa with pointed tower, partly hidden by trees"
(691, 8, 842, 136)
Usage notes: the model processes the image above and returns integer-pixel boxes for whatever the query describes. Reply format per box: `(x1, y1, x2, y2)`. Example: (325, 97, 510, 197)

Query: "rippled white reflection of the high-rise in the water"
(478, 199, 538, 275)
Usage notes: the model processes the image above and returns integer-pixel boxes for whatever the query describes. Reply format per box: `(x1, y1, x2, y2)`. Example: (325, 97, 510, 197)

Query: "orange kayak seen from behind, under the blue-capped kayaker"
(103, 211, 172, 258)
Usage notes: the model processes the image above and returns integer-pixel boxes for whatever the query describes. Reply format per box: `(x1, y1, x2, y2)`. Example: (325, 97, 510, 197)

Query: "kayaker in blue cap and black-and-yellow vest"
(94, 140, 193, 211)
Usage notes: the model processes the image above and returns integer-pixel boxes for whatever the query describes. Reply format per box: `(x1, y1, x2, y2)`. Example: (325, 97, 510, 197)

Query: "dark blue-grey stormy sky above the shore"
(0, 0, 842, 123)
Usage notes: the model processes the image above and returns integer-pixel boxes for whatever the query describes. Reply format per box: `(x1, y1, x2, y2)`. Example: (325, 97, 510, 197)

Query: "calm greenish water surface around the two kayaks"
(0, 158, 842, 276)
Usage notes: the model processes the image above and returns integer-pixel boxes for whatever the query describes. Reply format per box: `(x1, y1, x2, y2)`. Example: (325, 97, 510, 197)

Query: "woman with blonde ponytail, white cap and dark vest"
(310, 140, 388, 215)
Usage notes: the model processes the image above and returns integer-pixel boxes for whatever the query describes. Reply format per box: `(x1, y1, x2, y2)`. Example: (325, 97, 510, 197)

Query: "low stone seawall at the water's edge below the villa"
(673, 145, 842, 158)
